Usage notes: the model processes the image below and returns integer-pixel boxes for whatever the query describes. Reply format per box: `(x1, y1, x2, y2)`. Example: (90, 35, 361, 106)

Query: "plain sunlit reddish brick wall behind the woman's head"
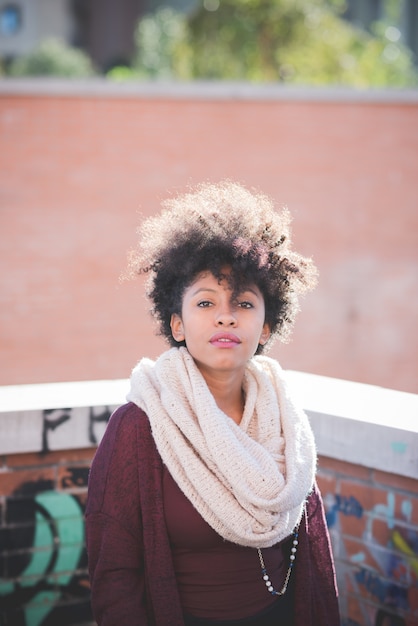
(0, 85, 418, 392)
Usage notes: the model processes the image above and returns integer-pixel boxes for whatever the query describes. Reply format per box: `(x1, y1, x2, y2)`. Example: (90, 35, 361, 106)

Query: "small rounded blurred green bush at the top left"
(5, 38, 95, 78)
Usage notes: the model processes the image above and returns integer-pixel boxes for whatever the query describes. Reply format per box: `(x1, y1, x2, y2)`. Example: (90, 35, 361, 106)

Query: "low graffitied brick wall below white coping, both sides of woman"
(0, 449, 418, 626)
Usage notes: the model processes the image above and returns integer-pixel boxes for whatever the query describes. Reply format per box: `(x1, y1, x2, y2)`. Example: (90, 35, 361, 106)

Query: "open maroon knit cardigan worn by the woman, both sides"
(86, 403, 340, 626)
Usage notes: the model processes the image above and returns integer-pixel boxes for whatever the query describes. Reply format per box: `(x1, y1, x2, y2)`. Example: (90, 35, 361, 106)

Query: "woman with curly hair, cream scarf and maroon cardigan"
(86, 181, 339, 626)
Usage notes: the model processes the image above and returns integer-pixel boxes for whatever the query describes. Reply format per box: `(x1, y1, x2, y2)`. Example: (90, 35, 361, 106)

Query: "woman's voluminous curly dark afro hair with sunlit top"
(129, 180, 317, 353)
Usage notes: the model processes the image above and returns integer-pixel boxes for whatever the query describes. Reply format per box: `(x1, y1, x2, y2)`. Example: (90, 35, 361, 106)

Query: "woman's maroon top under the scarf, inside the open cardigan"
(163, 467, 290, 619)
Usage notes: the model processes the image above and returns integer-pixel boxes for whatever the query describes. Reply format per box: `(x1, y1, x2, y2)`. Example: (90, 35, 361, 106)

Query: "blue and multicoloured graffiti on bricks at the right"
(324, 492, 418, 626)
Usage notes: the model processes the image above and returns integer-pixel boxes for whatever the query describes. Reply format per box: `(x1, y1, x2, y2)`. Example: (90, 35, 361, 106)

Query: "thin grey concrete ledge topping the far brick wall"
(0, 78, 418, 104)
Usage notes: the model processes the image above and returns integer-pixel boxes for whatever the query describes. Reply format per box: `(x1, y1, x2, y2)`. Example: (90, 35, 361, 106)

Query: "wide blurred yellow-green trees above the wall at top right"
(124, 0, 418, 88)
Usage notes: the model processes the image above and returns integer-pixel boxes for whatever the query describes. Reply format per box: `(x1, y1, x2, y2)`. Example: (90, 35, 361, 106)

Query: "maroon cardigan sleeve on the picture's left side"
(86, 405, 149, 626)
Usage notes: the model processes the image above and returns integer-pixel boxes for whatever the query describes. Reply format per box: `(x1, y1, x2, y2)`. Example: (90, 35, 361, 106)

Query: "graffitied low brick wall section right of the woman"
(318, 457, 418, 626)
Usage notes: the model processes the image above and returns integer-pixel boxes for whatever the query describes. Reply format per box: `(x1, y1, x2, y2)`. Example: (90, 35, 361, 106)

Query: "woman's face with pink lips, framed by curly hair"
(171, 272, 270, 377)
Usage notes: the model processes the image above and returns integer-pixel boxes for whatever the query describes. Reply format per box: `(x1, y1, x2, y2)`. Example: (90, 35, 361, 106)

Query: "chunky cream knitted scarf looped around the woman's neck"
(127, 348, 316, 548)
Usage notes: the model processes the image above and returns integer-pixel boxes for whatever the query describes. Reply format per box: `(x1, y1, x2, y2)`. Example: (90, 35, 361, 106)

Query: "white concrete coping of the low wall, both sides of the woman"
(0, 371, 418, 478)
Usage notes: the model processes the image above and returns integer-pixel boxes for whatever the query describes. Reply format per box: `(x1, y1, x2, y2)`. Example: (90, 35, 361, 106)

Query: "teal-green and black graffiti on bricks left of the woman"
(0, 468, 91, 626)
